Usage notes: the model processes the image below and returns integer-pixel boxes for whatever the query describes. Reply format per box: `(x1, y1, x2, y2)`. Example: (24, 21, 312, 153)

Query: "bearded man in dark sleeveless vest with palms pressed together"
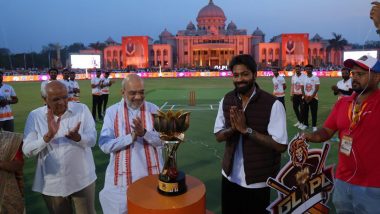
(214, 55, 288, 214)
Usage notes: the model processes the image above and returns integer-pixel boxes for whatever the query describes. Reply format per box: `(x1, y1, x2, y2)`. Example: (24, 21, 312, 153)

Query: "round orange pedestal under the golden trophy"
(127, 175, 206, 214)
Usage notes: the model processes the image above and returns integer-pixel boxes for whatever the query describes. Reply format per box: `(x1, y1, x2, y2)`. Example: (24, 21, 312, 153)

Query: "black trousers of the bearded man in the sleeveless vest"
(222, 176, 270, 214)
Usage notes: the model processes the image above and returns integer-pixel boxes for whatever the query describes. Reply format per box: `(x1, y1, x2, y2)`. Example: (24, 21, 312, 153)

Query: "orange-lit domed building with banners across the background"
(103, 0, 343, 69)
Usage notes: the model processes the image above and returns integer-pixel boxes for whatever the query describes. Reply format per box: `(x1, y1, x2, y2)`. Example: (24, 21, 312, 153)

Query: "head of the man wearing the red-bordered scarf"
(121, 74, 145, 109)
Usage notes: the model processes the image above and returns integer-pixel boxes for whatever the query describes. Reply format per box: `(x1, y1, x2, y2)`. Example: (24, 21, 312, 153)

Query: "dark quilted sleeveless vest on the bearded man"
(222, 85, 281, 184)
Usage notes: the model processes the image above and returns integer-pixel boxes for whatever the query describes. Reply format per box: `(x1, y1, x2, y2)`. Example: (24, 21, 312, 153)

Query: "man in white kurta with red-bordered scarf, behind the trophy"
(99, 74, 163, 214)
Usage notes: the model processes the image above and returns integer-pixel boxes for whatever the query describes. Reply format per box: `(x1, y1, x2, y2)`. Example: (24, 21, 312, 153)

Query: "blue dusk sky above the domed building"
(0, 0, 380, 53)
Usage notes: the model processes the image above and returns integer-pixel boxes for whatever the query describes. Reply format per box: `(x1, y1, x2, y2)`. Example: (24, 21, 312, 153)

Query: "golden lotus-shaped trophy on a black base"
(153, 110, 190, 196)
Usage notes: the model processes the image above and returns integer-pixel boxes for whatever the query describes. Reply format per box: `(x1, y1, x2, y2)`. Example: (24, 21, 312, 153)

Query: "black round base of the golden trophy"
(157, 171, 187, 196)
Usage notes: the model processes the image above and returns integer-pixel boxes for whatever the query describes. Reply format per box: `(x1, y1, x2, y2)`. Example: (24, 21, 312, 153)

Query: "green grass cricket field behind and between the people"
(9, 77, 339, 214)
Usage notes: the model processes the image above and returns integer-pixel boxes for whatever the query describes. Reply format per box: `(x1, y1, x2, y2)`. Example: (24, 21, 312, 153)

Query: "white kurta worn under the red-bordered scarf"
(99, 100, 163, 214)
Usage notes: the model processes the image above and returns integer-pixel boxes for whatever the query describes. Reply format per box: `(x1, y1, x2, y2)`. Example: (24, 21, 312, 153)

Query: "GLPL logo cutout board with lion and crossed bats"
(267, 135, 334, 214)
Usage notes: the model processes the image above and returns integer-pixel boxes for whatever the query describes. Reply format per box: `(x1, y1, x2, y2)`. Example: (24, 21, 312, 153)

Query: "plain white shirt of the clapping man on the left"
(22, 102, 96, 197)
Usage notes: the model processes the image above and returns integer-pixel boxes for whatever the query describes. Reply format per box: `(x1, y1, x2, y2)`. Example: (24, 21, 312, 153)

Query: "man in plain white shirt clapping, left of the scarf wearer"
(22, 80, 96, 213)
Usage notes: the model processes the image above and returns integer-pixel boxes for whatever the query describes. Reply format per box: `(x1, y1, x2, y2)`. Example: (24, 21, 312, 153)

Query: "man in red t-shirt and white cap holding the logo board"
(302, 56, 380, 213)
